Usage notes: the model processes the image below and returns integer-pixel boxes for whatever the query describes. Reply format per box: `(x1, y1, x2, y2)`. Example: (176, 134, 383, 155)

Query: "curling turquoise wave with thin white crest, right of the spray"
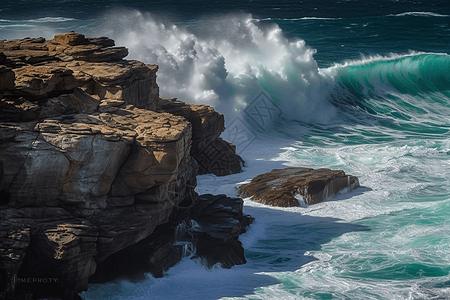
(321, 52, 450, 132)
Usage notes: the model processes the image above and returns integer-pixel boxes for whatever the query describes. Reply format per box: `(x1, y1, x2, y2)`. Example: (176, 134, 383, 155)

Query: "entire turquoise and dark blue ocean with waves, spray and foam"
(0, 0, 450, 300)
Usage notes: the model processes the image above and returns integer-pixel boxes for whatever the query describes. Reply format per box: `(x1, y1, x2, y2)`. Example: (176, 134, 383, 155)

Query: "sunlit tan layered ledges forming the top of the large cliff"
(0, 32, 169, 142)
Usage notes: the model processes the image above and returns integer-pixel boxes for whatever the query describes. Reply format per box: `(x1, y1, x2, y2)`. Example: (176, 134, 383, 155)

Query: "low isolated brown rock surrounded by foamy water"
(239, 168, 359, 207)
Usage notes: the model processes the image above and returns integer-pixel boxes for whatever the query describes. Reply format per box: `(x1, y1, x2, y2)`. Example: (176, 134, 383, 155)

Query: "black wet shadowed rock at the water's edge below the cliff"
(90, 195, 254, 283)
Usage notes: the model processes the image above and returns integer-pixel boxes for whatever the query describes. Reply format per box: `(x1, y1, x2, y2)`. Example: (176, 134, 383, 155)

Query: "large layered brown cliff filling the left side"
(0, 32, 246, 299)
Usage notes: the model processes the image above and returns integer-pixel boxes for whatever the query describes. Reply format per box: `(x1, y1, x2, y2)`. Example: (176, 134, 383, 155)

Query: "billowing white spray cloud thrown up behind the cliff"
(99, 11, 335, 123)
